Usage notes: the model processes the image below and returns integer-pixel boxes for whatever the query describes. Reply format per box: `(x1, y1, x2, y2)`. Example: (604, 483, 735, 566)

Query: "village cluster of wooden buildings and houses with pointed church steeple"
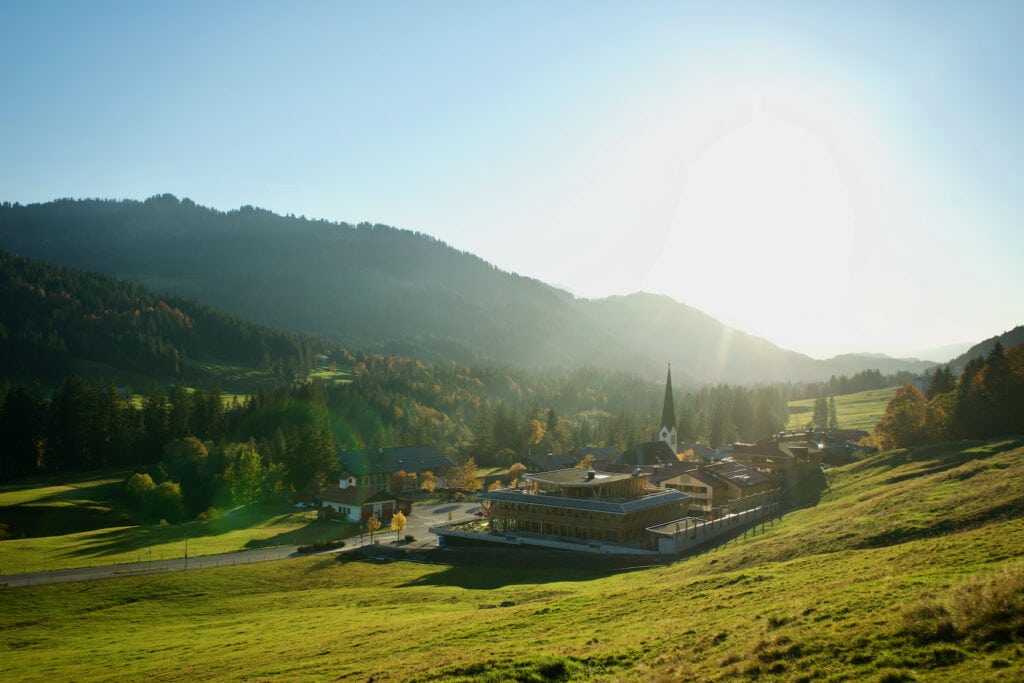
(318, 369, 864, 556)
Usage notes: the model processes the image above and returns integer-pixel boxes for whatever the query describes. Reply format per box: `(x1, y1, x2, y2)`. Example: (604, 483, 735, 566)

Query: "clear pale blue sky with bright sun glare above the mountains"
(0, 0, 1024, 360)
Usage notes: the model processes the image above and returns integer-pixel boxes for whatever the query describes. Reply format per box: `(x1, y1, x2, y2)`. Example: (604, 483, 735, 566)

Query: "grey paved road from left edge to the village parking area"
(0, 503, 480, 589)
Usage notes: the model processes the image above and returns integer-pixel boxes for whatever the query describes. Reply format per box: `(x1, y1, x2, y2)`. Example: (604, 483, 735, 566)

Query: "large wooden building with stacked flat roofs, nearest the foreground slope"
(480, 468, 688, 548)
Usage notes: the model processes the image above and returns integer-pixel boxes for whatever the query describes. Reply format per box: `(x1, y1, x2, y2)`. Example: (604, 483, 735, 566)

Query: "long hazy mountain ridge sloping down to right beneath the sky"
(0, 195, 937, 383)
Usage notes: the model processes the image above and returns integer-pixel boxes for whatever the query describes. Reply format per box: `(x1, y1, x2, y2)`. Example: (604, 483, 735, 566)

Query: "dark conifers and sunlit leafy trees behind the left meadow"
(0, 375, 338, 521)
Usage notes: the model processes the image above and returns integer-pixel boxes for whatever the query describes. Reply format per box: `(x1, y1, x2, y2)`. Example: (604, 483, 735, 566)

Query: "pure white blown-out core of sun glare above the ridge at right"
(645, 83, 855, 358)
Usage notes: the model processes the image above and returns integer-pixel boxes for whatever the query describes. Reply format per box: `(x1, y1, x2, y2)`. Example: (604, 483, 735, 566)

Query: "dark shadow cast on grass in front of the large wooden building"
(352, 546, 657, 590)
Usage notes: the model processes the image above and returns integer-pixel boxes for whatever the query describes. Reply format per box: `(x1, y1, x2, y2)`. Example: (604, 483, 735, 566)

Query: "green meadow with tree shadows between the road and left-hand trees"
(0, 472, 353, 574)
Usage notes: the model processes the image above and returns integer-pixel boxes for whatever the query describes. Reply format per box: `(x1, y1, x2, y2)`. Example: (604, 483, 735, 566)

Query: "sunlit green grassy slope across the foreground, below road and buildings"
(0, 439, 1024, 682)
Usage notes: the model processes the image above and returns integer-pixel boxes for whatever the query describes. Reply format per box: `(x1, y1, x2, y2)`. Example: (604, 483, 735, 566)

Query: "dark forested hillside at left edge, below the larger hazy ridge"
(0, 250, 316, 383)
